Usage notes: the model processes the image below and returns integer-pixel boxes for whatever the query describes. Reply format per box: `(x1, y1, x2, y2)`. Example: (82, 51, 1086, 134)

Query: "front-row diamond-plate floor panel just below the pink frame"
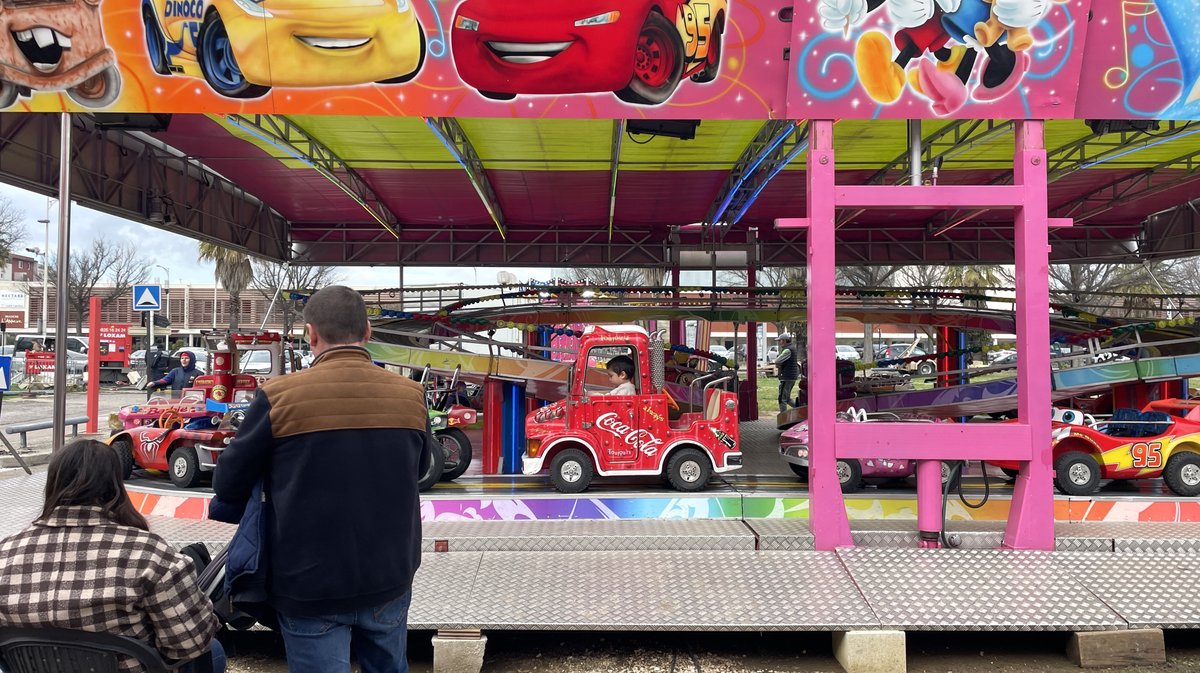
(836, 548, 1128, 631)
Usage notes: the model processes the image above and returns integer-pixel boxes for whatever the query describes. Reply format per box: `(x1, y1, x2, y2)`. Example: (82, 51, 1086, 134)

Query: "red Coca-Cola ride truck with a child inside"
(523, 325, 742, 493)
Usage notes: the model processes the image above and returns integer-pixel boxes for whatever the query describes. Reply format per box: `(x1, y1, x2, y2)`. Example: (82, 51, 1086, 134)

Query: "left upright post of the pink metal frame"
(805, 120, 853, 549)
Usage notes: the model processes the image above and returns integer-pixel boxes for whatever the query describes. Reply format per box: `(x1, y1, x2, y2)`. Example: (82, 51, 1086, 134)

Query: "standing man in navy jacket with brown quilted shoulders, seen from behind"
(212, 286, 432, 673)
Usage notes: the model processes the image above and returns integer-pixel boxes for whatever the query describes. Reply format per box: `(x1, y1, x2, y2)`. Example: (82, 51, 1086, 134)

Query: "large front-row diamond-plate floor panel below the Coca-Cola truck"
(453, 552, 878, 631)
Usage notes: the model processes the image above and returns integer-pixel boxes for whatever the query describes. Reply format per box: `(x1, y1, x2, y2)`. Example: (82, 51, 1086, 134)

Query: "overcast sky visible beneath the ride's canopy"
(0, 185, 554, 288)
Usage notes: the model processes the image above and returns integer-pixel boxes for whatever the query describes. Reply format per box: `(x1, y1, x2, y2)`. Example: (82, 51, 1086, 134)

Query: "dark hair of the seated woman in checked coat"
(38, 439, 150, 530)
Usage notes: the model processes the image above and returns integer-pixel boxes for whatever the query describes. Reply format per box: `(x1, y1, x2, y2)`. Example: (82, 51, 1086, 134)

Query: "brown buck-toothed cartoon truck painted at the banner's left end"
(0, 0, 121, 108)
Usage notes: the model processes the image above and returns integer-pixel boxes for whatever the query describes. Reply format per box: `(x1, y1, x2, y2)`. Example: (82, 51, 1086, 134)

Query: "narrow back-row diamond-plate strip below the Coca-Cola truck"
(421, 519, 755, 552)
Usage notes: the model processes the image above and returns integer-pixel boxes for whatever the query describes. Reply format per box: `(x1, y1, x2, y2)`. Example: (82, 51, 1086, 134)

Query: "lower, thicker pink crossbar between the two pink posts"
(835, 422, 1032, 461)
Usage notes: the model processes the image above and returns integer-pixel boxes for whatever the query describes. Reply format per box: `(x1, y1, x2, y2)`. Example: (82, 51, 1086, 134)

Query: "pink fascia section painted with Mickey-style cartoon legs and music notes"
(787, 0, 1200, 119)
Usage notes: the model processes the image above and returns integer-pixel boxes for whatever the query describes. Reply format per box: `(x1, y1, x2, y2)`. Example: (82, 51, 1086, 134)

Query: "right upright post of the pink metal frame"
(1004, 121, 1055, 549)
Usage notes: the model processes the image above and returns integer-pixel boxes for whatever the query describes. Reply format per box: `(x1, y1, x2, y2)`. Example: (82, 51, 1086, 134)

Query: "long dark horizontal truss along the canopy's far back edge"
(285, 223, 1138, 269)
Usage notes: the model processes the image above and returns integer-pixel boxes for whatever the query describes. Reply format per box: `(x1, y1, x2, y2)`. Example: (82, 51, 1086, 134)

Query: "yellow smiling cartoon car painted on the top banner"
(142, 0, 425, 98)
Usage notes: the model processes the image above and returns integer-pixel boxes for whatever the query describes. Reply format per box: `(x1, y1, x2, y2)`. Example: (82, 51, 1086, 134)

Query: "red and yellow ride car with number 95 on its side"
(991, 399, 1200, 497)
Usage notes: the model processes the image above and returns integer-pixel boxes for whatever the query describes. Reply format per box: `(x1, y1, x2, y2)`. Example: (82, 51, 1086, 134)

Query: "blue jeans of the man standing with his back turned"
(280, 590, 413, 673)
